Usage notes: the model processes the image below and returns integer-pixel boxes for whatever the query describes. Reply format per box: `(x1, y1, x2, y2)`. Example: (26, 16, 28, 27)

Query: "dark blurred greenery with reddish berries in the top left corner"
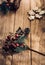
(0, 0, 21, 14)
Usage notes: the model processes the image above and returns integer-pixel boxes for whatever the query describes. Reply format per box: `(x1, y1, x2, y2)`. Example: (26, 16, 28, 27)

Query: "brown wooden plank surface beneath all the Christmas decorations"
(0, 0, 45, 65)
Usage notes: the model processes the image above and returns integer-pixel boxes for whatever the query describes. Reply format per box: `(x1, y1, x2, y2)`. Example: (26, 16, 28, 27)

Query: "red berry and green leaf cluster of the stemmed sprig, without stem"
(2, 27, 30, 53)
